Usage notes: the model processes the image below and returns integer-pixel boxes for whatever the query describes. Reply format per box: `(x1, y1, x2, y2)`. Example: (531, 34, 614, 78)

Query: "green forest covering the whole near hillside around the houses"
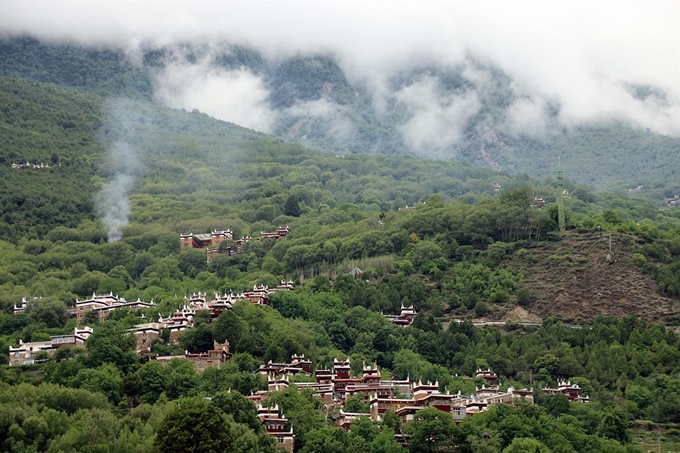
(0, 67, 680, 453)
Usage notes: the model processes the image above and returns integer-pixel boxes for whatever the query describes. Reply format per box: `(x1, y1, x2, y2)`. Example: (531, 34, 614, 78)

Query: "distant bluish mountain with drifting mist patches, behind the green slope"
(0, 37, 680, 197)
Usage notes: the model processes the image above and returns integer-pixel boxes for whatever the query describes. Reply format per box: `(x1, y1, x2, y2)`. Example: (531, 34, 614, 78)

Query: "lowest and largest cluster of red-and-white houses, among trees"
(247, 355, 588, 452)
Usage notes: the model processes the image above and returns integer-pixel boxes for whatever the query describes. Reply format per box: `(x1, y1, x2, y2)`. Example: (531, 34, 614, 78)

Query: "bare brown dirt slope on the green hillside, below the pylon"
(504, 232, 680, 324)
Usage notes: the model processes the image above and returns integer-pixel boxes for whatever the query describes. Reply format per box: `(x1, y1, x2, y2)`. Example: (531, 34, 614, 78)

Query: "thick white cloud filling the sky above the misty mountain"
(0, 0, 680, 135)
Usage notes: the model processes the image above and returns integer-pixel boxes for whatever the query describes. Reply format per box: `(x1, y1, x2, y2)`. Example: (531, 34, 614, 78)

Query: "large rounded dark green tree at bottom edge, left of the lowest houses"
(154, 400, 234, 453)
